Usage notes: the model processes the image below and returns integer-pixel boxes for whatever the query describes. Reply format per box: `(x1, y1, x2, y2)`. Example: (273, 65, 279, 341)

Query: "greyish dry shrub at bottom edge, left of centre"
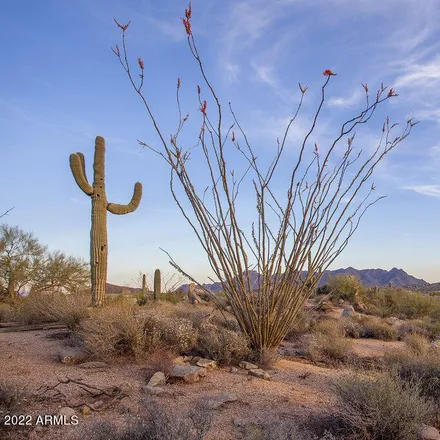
(87, 398, 212, 440)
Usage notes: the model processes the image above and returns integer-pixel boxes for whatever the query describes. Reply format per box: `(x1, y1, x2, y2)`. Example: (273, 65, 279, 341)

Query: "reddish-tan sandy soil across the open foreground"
(0, 330, 399, 440)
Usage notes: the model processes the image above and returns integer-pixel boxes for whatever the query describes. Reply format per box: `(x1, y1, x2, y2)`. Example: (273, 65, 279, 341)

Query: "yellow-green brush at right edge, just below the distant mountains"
(363, 287, 440, 319)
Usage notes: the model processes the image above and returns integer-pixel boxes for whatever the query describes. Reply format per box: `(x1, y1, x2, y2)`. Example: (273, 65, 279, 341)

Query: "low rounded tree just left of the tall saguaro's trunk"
(31, 251, 90, 293)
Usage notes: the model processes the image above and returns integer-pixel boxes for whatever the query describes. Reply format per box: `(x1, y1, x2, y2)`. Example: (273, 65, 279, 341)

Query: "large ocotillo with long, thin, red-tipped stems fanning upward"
(113, 4, 415, 350)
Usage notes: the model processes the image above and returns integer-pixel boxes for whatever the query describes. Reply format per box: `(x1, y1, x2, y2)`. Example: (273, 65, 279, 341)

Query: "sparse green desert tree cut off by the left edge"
(0, 224, 46, 299)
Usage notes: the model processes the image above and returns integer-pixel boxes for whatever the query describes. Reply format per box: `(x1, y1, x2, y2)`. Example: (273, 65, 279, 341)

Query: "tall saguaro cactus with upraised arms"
(70, 136, 142, 307)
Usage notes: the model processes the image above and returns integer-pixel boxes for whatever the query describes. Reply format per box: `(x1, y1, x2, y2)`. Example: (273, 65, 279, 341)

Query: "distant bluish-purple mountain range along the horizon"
(106, 267, 434, 294)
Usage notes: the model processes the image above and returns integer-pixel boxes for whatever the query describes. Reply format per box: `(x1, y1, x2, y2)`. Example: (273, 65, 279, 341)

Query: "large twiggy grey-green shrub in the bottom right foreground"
(336, 374, 433, 440)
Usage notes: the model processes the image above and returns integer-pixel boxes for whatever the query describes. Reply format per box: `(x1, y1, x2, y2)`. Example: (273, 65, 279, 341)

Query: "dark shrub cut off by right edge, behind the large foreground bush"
(385, 347, 440, 402)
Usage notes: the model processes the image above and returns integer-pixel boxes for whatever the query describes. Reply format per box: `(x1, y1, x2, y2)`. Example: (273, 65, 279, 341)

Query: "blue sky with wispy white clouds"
(0, 0, 440, 283)
